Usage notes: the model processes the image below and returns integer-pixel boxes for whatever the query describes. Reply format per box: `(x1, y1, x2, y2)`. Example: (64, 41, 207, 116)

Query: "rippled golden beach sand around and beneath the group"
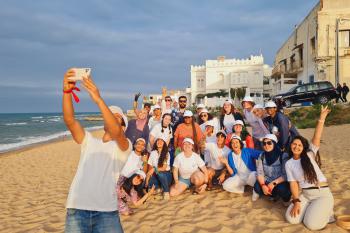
(0, 125, 350, 233)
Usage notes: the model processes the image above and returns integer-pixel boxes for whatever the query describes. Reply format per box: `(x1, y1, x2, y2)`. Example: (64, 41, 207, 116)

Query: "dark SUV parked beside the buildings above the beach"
(272, 81, 337, 107)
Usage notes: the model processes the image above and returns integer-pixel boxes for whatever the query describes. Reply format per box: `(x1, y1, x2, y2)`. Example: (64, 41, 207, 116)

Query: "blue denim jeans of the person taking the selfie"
(64, 209, 124, 233)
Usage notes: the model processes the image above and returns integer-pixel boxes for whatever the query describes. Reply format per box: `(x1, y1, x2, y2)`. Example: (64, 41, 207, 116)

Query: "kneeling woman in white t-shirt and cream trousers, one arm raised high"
(286, 107, 334, 230)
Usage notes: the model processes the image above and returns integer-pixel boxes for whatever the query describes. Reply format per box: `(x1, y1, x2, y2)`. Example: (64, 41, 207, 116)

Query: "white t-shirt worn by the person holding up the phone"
(66, 131, 132, 211)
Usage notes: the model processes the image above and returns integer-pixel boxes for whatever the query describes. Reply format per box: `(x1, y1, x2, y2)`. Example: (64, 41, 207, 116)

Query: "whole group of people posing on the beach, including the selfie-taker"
(63, 70, 334, 232)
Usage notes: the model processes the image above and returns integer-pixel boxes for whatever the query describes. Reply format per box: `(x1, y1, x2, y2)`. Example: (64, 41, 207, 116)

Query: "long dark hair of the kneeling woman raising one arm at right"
(288, 135, 321, 184)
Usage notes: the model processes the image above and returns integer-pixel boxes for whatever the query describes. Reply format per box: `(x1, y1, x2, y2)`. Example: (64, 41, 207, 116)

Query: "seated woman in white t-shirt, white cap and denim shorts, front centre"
(170, 138, 208, 196)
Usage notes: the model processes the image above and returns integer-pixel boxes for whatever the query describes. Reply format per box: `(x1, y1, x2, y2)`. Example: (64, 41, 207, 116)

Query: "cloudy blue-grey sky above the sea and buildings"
(0, 0, 318, 113)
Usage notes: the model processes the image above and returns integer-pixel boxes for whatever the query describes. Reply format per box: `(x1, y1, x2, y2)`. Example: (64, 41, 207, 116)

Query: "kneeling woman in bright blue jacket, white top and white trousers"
(220, 135, 261, 193)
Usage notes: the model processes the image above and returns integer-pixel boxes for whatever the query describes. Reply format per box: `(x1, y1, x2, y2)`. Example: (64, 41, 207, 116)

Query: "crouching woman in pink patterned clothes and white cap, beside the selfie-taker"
(116, 170, 155, 215)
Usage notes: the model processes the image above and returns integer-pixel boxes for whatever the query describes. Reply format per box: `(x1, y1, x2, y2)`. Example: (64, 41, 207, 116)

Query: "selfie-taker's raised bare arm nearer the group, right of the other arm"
(82, 78, 129, 151)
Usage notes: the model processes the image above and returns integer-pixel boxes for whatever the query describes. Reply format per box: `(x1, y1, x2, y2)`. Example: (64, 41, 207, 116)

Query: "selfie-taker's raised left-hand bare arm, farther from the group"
(62, 69, 85, 144)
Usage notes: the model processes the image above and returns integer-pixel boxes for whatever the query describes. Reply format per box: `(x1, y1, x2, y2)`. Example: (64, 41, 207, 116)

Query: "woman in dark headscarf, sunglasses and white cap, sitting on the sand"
(252, 134, 291, 205)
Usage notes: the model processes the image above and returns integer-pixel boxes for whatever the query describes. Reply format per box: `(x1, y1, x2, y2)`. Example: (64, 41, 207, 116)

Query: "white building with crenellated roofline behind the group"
(191, 55, 271, 107)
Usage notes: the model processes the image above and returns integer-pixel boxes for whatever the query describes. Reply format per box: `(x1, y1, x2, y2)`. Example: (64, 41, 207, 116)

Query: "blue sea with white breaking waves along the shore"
(0, 112, 103, 153)
